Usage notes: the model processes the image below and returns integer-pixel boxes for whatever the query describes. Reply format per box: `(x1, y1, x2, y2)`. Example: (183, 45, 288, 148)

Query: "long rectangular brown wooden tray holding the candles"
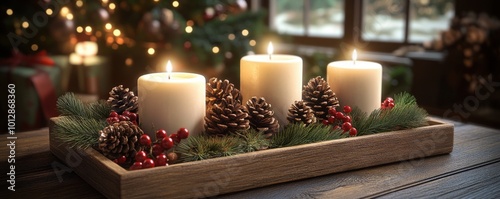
(50, 118, 453, 198)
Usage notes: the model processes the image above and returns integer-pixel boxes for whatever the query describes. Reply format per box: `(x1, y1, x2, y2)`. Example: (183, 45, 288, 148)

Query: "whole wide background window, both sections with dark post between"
(267, 0, 454, 51)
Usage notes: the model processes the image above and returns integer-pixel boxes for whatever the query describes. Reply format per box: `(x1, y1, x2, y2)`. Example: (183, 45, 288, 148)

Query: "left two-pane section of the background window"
(270, 0, 345, 38)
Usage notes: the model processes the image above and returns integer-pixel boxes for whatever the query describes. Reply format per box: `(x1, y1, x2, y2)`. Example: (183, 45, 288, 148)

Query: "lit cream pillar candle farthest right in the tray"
(327, 50, 382, 114)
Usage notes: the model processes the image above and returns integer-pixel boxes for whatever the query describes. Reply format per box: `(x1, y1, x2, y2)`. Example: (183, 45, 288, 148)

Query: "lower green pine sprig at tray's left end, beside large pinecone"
(54, 116, 107, 149)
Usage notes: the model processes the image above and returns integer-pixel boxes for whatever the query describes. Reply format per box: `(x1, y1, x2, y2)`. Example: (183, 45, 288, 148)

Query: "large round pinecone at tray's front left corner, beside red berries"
(98, 121, 144, 160)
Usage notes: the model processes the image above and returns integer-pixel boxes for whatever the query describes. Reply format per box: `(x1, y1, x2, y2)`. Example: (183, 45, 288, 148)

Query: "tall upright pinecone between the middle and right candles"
(302, 76, 339, 120)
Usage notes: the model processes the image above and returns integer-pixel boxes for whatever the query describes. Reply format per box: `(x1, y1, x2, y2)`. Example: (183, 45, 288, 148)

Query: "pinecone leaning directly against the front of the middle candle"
(245, 97, 280, 137)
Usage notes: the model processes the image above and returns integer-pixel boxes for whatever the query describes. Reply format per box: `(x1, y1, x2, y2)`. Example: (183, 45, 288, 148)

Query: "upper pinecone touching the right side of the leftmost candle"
(206, 77, 242, 110)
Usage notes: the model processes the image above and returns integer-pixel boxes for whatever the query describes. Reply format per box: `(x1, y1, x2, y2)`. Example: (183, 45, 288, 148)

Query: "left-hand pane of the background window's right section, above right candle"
(362, 0, 405, 42)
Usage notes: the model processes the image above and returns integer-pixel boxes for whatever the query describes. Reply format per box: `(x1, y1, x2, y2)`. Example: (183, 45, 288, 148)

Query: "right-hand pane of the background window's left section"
(308, 0, 344, 37)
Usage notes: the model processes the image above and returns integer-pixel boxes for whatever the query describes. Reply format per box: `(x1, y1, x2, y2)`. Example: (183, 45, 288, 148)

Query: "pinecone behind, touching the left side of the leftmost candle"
(107, 85, 138, 114)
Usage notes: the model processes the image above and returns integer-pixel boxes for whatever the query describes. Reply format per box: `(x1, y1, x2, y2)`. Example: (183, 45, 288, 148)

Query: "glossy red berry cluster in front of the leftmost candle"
(128, 128, 189, 170)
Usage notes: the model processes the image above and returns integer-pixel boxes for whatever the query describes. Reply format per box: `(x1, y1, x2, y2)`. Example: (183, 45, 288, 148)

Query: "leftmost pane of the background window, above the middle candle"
(271, 0, 305, 35)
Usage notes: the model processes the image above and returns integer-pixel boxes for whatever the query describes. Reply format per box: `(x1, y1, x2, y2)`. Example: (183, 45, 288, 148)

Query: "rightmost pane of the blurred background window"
(408, 0, 454, 42)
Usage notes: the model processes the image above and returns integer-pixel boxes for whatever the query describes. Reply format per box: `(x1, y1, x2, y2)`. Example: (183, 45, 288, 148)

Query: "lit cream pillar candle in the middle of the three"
(240, 43, 302, 126)
